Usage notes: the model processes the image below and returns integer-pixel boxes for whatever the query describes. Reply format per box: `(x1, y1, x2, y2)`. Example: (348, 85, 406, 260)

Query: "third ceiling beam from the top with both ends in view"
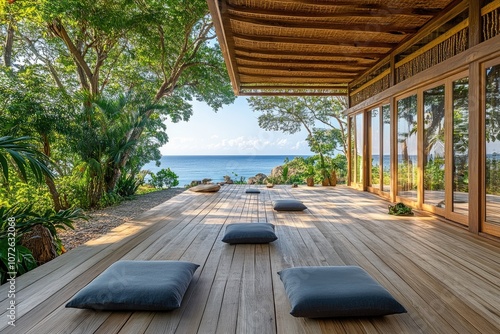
(234, 46, 386, 60)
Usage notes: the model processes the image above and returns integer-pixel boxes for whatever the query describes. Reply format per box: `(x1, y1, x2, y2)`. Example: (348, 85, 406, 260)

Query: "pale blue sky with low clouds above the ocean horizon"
(160, 97, 311, 155)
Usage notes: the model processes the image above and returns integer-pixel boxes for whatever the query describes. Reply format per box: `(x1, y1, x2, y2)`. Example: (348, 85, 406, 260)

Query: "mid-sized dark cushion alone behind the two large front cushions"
(222, 223, 278, 244)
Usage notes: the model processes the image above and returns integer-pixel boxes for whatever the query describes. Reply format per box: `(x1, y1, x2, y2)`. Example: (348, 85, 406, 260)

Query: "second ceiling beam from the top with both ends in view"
(233, 33, 398, 49)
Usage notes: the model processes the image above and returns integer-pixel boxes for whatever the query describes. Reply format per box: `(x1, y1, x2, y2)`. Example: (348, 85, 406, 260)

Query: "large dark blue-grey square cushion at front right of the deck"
(278, 266, 406, 318)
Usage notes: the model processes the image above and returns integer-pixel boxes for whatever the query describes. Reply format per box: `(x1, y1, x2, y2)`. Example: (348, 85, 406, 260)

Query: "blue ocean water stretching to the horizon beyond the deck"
(142, 155, 305, 187)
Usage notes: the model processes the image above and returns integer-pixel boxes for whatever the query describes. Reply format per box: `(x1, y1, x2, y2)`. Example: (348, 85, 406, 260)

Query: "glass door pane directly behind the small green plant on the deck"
(397, 94, 418, 201)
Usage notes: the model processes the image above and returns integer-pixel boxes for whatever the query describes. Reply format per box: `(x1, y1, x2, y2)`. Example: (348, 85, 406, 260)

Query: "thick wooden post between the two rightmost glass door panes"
(469, 61, 484, 234)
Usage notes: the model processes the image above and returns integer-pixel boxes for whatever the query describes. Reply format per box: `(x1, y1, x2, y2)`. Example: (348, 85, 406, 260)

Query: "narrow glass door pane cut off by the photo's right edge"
(484, 65, 500, 227)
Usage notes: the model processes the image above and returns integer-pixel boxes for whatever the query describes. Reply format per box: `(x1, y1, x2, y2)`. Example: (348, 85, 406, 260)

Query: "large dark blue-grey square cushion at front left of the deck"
(66, 261, 199, 311)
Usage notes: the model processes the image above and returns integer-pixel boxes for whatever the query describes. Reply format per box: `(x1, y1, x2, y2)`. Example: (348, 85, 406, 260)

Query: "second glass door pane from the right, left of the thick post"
(452, 78, 469, 215)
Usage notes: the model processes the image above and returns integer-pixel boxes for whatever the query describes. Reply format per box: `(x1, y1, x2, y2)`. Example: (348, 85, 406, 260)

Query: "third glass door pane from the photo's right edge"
(423, 85, 447, 208)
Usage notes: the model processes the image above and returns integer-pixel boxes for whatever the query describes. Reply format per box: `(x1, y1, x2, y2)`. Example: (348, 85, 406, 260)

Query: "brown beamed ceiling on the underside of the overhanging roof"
(207, 0, 457, 95)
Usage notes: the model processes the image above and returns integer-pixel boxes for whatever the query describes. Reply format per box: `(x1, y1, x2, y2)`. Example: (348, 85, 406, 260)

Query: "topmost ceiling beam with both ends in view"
(229, 14, 418, 35)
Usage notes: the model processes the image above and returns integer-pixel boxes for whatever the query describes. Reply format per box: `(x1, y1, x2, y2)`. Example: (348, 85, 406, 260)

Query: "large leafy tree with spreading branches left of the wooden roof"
(0, 0, 235, 207)
